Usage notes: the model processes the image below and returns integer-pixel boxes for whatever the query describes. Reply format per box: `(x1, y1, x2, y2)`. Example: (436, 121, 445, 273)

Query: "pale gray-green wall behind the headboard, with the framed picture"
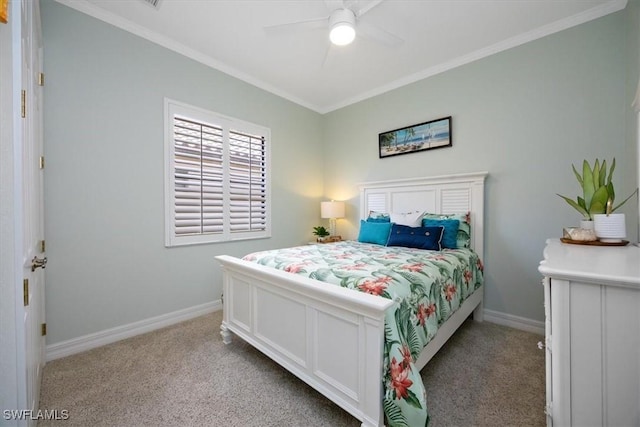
(324, 11, 638, 321)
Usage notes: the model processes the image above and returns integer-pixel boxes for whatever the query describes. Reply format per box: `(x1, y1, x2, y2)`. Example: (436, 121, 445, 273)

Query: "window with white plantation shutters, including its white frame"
(165, 99, 271, 246)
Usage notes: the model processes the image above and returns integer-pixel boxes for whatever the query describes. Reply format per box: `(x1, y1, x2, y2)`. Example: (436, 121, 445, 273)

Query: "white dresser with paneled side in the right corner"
(538, 239, 640, 427)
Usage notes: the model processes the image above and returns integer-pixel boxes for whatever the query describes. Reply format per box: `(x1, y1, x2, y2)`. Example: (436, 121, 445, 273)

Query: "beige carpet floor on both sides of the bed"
(38, 312, 545, 427)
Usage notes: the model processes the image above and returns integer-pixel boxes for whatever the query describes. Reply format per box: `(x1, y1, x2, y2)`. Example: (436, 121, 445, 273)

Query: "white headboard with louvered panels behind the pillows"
(358, 172, 488, 260)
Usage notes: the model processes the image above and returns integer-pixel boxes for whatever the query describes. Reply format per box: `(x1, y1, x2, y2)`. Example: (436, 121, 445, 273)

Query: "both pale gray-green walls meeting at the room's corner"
(42, 0, 638, 344)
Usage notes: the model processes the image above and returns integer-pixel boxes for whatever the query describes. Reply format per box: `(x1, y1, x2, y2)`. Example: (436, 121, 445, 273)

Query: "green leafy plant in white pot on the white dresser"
(558, 158, 638, 240)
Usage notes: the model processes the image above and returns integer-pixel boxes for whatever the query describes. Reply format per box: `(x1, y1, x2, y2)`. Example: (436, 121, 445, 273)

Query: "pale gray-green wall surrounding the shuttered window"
(42, 0, 323, 344)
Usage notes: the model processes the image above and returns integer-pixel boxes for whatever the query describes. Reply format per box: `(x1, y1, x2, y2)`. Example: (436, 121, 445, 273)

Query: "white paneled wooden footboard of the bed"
(216, 255, 394, 426)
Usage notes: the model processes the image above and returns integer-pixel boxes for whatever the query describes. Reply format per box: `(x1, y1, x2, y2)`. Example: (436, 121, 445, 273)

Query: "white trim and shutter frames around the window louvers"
(164, 98, 271, 247)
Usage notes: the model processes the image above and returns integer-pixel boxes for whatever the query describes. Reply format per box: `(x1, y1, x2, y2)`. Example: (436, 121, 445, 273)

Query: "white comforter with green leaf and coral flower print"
(244, 241, 483, 427)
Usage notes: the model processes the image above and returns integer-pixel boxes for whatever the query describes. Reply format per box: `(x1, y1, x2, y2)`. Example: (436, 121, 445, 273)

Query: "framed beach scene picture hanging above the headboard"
(378, 116, 453, 159)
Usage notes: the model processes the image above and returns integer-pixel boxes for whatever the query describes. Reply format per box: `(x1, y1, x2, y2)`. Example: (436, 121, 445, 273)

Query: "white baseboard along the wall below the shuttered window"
(46, 300, 222, 361)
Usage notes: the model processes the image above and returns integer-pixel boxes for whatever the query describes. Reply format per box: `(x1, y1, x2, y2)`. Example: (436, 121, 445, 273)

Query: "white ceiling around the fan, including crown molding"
(58, 0, 627, 113)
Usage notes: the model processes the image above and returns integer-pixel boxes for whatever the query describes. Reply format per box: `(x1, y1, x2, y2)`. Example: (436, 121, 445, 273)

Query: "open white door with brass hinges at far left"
(21, 0, 46, 425)
